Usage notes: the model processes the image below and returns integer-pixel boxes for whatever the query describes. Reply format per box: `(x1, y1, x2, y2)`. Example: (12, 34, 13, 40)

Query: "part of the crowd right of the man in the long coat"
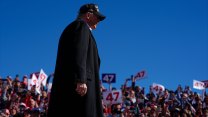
(103, 78, 208, 117)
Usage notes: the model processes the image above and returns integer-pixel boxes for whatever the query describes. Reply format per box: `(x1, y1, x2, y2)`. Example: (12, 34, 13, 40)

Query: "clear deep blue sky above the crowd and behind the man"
(0, 0, 208, 91)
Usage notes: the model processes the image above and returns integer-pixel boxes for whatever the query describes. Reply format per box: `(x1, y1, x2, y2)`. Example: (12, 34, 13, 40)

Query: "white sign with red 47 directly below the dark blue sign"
(103, 90, 122, 104)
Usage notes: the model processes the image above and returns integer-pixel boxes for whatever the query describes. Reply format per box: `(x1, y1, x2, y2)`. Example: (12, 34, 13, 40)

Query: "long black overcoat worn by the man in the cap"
(47, 19, 103, 117)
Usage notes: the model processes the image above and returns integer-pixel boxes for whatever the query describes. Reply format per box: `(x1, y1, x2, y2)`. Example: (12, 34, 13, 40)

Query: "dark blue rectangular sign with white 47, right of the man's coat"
(102, 73, 116, 83)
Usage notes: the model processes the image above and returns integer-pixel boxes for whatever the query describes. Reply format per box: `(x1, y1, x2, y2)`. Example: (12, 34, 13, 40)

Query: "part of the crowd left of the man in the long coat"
(0, 75, 48, 117)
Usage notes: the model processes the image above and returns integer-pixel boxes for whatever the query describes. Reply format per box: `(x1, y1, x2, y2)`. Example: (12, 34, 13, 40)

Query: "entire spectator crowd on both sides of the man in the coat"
(0, 75, 208, 117)
